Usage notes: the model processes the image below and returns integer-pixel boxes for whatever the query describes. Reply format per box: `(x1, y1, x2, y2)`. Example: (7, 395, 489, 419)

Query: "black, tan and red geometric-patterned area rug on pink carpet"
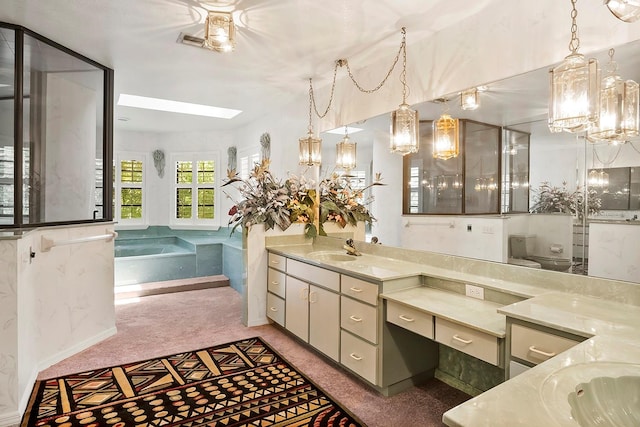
(21, 338, 364, 427)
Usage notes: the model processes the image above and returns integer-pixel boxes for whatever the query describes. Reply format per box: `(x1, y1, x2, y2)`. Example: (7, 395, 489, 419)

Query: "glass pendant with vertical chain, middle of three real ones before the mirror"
(390, 28, 418, 155)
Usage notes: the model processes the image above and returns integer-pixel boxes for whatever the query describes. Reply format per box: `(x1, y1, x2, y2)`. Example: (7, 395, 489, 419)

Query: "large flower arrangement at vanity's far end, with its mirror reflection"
(222, 159, 382, 237)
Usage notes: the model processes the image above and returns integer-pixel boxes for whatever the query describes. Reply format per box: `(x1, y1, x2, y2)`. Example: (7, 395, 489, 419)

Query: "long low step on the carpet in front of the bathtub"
(114, 274, 229, 300)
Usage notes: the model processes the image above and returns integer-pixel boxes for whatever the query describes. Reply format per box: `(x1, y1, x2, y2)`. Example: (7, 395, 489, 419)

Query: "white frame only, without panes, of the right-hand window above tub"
(169, 151, 224, 230)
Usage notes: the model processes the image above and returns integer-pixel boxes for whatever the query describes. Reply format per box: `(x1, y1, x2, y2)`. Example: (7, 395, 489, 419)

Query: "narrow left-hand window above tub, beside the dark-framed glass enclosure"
(115, 153, 146, 225)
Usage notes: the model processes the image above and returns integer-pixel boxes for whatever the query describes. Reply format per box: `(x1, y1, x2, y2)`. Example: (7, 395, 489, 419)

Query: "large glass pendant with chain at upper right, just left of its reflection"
(549, 0, 600, 132)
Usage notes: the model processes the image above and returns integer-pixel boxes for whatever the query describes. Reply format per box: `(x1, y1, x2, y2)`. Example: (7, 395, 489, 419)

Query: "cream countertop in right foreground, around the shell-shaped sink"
(443, 292, 640, 427)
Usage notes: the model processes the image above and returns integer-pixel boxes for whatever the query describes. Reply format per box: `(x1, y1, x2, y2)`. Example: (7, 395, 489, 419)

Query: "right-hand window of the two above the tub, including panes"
(172, 153, 219, 226)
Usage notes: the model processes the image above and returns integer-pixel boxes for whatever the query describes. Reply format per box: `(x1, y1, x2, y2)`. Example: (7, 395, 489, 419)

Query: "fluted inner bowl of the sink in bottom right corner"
(569, 375, 640, 427)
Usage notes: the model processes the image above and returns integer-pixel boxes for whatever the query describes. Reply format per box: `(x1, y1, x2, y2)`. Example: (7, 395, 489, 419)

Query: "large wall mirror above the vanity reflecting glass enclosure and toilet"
(322, 38, 640, 283)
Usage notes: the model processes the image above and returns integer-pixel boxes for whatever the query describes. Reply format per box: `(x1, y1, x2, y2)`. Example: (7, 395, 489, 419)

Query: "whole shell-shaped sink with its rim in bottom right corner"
(540, 362, 640, 427)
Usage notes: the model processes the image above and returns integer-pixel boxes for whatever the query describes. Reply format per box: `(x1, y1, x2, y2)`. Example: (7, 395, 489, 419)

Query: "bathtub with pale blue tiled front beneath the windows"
(114, 237, 198, 286)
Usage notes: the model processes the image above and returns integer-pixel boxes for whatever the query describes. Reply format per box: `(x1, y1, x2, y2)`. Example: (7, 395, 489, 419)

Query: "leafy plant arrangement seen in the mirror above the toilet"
(531, 182, 602, 220)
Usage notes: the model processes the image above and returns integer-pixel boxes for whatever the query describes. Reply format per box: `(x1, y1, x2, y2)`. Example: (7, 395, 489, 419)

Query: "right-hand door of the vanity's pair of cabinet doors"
(308, 285, 340, 361)
